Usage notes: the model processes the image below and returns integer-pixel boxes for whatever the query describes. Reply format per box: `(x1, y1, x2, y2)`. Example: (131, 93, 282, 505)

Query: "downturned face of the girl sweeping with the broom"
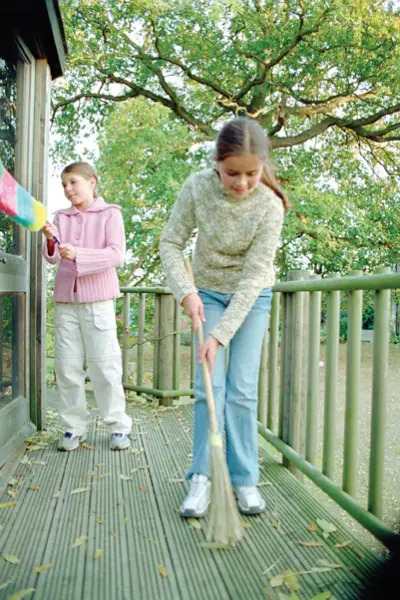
(217, 154, 263, 198)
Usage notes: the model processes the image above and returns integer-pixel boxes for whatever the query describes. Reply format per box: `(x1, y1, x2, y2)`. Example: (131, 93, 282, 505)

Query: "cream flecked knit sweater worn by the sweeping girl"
(160, 169, 283, 346)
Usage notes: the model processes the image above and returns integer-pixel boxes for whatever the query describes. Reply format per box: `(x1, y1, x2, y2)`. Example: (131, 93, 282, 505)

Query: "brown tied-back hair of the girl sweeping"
(215, 117, 290, 211)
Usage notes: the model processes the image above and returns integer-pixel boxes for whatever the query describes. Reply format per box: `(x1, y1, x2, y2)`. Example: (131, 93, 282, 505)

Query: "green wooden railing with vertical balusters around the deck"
(122, 268, 400, 543)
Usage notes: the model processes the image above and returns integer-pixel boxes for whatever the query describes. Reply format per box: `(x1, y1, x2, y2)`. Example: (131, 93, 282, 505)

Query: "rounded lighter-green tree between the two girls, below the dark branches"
(96, 99, 205, 285)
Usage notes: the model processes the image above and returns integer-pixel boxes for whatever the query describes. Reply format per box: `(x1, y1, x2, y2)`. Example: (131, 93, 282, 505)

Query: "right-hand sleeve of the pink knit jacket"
(75, 208, 125, 277)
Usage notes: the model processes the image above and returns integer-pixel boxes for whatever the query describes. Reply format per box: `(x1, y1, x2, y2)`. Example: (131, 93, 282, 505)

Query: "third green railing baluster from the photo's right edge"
(322, 273, 340, 480)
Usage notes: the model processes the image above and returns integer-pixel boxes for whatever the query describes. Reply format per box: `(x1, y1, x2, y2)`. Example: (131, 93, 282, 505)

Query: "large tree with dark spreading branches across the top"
(54, 0, 400, 160)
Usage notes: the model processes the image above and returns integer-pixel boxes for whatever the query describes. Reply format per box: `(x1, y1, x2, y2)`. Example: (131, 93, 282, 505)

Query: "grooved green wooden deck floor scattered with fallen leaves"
(0, 398, 378, 600)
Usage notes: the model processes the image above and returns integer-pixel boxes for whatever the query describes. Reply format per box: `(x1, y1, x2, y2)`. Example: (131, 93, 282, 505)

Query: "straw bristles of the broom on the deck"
(207, 433, 243, 546)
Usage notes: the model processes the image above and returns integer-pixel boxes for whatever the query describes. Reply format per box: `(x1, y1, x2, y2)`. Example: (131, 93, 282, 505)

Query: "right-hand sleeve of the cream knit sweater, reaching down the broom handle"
(211, 197, 283, 346)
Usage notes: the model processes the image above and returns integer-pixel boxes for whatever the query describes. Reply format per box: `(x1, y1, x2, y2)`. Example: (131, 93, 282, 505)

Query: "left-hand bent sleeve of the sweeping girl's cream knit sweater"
(160, 177, 197, 302)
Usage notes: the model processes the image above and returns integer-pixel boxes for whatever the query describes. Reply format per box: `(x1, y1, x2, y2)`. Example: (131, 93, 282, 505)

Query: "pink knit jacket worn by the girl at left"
(43, 197, 125, 302)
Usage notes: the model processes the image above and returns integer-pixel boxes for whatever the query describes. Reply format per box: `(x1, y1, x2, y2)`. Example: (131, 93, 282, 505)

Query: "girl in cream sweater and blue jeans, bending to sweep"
(160, 118, 288, 536)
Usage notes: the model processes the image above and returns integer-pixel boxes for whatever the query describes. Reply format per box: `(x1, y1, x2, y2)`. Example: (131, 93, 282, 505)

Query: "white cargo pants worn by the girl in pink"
(55, 300, 132, 435)
